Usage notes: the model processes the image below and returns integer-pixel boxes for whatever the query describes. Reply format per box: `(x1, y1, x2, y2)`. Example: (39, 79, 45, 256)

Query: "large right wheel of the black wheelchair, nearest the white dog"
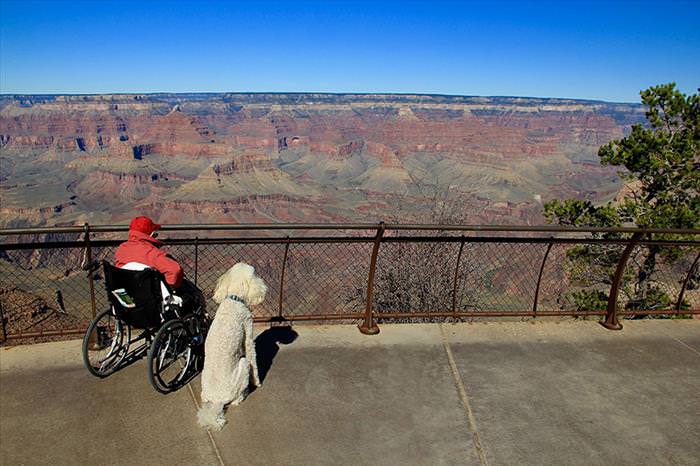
(148, 319, 194, 393)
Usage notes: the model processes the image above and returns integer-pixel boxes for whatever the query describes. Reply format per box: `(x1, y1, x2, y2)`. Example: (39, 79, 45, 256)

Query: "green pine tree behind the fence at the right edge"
(544, 83, 700, 310)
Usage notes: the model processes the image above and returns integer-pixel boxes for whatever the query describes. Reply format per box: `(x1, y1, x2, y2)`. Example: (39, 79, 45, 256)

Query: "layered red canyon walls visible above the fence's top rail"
(0, 93, 644, 228)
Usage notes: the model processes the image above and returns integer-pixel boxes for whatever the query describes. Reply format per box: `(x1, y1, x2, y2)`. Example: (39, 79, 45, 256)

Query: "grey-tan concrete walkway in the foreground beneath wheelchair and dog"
(0, 320, 700, 466)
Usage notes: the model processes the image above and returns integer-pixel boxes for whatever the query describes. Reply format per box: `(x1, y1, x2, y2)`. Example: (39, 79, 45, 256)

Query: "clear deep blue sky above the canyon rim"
(0, 0, 700, 102)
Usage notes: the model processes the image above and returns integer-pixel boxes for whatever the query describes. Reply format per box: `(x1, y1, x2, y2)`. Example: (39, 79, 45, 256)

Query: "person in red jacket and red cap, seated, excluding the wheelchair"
(115, 216, 203, 314)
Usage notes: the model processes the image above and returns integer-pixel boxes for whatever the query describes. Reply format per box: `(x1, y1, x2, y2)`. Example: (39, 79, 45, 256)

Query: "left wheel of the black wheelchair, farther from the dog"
(83, 309, 129, 377)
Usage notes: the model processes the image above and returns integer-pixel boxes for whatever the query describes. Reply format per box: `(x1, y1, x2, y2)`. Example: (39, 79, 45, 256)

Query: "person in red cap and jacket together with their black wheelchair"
(82, 217, 211, 393)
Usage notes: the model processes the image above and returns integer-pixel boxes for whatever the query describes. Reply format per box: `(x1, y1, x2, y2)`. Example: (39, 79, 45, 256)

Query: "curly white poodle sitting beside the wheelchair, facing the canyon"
(197, 263, 267, 430)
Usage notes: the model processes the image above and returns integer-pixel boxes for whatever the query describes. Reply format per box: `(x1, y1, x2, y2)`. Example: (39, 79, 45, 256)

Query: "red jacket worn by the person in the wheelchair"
(115, 230, 184, 288)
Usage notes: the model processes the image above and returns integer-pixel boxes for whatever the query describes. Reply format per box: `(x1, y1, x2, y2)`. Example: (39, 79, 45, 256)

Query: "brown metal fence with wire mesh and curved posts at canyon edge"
(0, 223, 700, 342)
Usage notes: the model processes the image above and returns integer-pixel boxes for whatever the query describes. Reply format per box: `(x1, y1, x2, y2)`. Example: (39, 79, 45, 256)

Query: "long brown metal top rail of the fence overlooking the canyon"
(0, 223, 700, 236)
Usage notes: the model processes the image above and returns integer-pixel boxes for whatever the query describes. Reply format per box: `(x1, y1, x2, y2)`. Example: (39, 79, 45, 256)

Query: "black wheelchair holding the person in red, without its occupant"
(82, 261, 211, 394)
